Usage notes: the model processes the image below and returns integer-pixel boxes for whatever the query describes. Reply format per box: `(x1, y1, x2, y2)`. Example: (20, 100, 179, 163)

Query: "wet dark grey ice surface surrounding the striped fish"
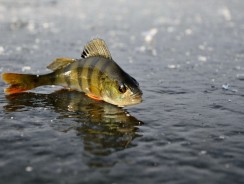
(0, 0, 244, 184)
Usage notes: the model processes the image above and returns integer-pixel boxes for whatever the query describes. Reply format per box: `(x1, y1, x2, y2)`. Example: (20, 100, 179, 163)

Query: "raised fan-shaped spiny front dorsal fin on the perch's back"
(81, 38, 112, 59)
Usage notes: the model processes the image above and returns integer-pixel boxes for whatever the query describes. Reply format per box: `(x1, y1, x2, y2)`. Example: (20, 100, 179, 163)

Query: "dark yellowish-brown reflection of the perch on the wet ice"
(4, 89, 143, 161)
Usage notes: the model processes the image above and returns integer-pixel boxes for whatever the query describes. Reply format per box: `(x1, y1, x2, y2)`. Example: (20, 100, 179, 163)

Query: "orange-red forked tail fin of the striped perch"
(2, 73, 39, 94)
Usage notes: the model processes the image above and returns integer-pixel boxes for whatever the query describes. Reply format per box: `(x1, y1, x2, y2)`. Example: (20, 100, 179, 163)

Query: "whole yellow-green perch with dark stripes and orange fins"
(1, 38, 143, 107)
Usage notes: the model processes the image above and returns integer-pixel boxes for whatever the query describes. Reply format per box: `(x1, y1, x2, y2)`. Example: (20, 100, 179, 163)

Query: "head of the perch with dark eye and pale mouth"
(103, 75, 142, 107)
